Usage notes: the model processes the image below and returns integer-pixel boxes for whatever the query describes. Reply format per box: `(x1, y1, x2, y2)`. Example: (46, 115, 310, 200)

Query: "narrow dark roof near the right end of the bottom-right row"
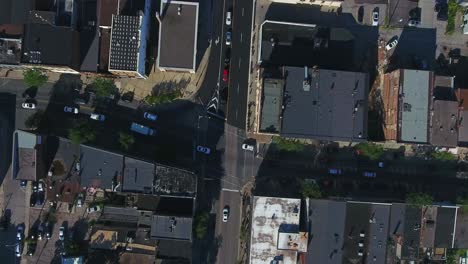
(434, 207, 456, 248)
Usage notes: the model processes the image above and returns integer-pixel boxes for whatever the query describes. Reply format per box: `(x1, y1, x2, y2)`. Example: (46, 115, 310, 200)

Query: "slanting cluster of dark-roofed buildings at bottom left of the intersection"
(12, 130, 197, 263)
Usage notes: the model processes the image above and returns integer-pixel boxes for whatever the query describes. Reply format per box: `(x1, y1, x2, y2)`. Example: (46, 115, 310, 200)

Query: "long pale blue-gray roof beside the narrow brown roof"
(399, 70, 433, 143)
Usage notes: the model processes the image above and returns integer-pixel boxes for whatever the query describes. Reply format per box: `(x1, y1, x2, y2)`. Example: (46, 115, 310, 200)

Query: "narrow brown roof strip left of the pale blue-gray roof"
(382, 70, 400, 140)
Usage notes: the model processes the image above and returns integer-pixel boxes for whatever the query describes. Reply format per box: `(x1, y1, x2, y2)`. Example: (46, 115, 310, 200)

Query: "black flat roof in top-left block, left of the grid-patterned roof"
(22, 24, 79, 69)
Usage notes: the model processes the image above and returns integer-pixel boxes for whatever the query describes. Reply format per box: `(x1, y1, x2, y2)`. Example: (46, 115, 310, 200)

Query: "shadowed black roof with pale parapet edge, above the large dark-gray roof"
(258, 21, 354, 70)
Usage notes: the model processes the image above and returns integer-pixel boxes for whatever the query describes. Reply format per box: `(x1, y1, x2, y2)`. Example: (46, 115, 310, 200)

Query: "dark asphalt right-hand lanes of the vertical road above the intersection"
(227, 0, 253, 129)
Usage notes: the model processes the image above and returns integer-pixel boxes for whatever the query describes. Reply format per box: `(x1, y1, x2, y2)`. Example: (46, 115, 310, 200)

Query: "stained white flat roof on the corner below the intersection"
(250, 196, 301, 264)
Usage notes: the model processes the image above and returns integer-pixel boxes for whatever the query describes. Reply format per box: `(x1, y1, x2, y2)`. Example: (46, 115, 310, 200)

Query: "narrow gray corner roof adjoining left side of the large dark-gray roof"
(260, 78, 284, 133)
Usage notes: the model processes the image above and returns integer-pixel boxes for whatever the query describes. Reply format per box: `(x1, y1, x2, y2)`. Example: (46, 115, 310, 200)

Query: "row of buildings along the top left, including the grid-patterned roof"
(0, 0, 198, 78)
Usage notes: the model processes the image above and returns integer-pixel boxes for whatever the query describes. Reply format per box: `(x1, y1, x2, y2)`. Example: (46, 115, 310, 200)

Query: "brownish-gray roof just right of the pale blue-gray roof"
(430, 100, 458, 147)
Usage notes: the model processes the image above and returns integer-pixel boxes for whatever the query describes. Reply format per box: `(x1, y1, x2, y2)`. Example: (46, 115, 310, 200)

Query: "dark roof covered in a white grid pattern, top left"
(109, 15, 142, 71)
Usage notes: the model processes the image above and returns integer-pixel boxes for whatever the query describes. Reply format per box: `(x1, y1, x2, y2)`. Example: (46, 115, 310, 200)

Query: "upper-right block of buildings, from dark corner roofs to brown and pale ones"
(254, 20, 468, 147)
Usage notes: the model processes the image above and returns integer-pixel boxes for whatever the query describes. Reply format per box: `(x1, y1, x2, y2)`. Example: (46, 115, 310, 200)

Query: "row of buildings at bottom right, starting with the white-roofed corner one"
(250, 196, 468, 264)
